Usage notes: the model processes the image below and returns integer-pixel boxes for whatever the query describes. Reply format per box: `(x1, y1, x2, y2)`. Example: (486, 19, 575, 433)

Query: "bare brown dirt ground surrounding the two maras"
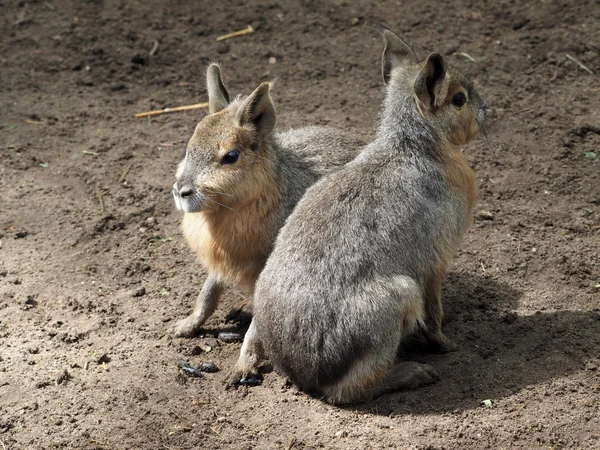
(0, 0, 600, 450)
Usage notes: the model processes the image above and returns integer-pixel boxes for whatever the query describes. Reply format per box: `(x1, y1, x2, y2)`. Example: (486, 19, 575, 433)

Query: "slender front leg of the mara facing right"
(423, 263, 456, 352)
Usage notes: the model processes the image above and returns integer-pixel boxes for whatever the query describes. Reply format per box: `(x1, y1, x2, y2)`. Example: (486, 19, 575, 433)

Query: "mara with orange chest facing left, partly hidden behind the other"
(173, 64, 364, 337)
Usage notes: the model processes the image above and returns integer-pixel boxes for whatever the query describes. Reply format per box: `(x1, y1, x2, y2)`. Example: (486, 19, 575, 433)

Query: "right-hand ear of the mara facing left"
(235, 83, 275, 136)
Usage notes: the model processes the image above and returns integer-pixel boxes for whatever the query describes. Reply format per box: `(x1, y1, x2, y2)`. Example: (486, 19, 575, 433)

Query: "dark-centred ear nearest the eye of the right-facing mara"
(414, 53, 448, 112)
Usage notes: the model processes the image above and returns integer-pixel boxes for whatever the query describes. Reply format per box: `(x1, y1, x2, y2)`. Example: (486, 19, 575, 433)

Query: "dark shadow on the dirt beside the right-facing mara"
(354, 273, 600, 415)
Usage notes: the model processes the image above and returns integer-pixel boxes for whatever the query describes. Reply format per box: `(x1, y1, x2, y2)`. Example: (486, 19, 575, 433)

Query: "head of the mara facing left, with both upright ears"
(173, 64, 275, 212)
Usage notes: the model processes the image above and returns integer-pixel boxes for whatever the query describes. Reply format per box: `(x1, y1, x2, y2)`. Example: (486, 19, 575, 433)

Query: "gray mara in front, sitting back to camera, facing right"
(234, 30, 486, 403)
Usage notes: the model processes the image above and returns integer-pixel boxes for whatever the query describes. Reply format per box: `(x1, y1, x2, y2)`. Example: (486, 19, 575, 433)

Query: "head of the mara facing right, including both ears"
(382, 29, 486, 145)
